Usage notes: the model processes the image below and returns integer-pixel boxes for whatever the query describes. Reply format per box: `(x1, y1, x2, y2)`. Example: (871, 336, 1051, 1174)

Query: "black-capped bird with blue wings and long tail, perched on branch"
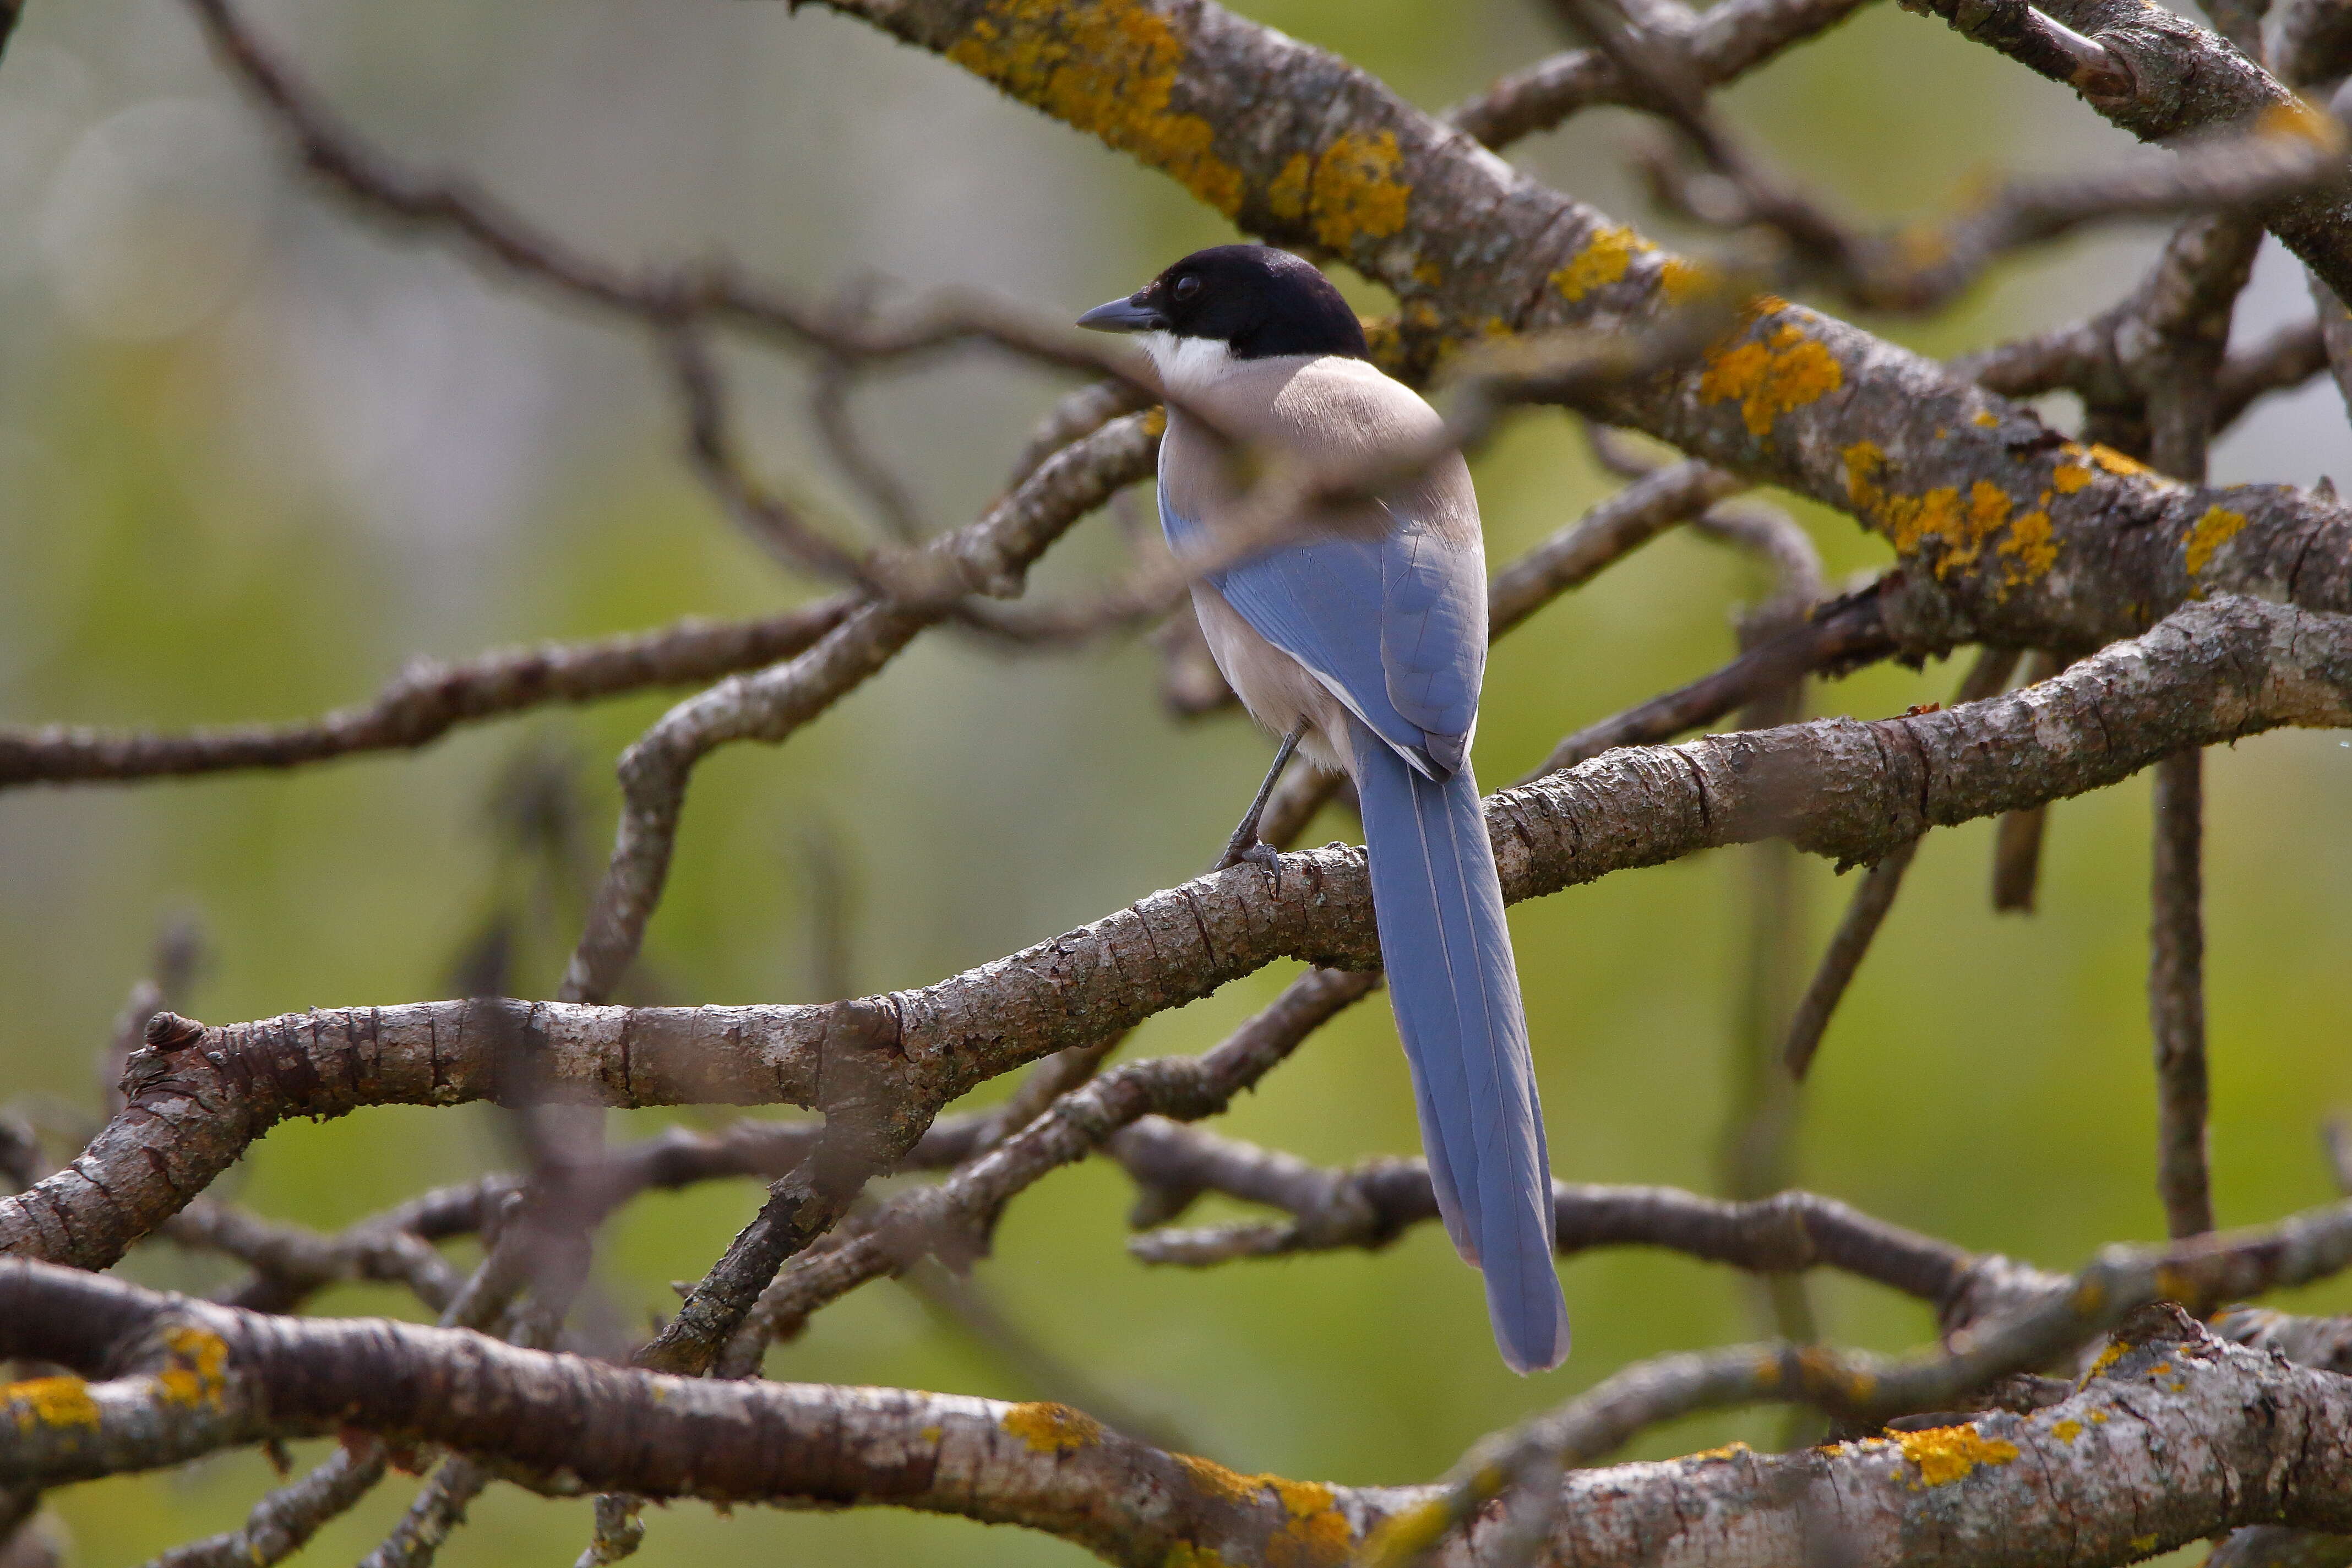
(1077, 244, 1569, 1373)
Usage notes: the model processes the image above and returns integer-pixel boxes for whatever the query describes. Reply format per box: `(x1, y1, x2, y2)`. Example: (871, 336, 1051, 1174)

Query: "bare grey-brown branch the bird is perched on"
(0, 600, 2352, 1267)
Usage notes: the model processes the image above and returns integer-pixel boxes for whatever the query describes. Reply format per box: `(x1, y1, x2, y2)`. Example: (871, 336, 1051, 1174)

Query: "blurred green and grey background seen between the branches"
(0, 0, 2352, 1566)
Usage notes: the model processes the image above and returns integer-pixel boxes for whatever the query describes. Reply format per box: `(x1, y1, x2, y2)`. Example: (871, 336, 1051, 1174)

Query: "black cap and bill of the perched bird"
(1077, 244, 1371, 360)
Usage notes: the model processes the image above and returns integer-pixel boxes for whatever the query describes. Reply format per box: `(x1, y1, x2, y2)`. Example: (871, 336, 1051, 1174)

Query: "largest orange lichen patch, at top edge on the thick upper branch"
(948, 0, 1242, 216)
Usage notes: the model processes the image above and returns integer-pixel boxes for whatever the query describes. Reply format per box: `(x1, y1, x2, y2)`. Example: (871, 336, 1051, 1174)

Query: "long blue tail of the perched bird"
(1352, 724, 1569, 1373)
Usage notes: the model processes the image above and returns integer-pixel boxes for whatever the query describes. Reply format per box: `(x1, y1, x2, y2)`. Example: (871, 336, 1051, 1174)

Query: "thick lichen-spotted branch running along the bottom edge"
(14, 1262, 2352, 1568)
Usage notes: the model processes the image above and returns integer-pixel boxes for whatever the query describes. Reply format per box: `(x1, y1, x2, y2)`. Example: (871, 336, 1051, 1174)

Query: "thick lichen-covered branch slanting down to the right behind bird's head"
(835, 0, 2352, 646)
